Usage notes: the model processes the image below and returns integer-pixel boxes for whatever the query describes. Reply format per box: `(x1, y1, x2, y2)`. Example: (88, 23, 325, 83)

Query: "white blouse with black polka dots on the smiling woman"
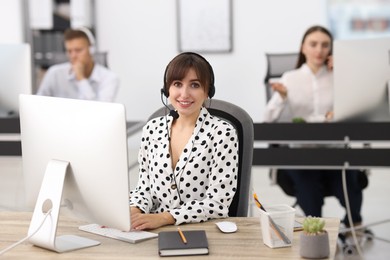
(130, 107, 238, 225)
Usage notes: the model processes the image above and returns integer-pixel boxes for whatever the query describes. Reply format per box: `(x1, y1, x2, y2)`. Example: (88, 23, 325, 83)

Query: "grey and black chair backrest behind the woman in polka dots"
(149, 99, 254, 217)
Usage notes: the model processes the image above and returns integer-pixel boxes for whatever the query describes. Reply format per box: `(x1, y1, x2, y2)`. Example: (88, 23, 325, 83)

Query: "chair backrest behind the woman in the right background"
(264, 53, 299, 101)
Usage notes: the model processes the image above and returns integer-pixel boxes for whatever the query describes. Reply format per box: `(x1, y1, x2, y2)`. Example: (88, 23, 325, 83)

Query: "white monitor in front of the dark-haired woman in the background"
(333, 37, 390, 121)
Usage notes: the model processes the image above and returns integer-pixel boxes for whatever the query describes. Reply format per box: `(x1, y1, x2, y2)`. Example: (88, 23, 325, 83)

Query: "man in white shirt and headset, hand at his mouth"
(37, 27, 119, 102)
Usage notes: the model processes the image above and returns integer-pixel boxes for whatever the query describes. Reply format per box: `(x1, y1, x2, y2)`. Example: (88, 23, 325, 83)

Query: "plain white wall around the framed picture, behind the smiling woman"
(95, 0, 326, 122)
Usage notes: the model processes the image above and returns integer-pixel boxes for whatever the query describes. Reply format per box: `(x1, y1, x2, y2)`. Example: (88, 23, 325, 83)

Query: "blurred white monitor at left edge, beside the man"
(0, 43, 32, 116)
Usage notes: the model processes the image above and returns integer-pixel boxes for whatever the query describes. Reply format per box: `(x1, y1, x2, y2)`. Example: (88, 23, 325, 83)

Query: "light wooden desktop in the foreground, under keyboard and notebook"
(0, 212, 340, 260)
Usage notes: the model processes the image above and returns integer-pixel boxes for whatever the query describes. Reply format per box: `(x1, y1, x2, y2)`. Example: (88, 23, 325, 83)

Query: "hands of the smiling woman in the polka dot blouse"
(130, 207, 175, 230)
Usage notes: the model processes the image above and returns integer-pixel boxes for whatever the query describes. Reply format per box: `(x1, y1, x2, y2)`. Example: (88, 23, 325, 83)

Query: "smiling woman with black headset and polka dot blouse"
(130, 52, 238, 230)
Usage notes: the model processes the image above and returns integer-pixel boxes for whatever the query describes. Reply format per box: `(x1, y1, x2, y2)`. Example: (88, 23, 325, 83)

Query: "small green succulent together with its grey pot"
(300, 216, 329, 259)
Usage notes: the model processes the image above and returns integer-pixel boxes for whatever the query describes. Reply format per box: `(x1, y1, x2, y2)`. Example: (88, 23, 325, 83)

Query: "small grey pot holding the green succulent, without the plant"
(300, 232, 329, 259)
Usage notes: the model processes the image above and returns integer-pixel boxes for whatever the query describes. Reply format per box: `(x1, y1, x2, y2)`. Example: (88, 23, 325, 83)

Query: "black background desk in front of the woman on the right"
(253, 122, 390, 169)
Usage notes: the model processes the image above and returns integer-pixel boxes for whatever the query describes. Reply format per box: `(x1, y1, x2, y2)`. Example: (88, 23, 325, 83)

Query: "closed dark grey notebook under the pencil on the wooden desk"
(158, 230, 209, 256)
